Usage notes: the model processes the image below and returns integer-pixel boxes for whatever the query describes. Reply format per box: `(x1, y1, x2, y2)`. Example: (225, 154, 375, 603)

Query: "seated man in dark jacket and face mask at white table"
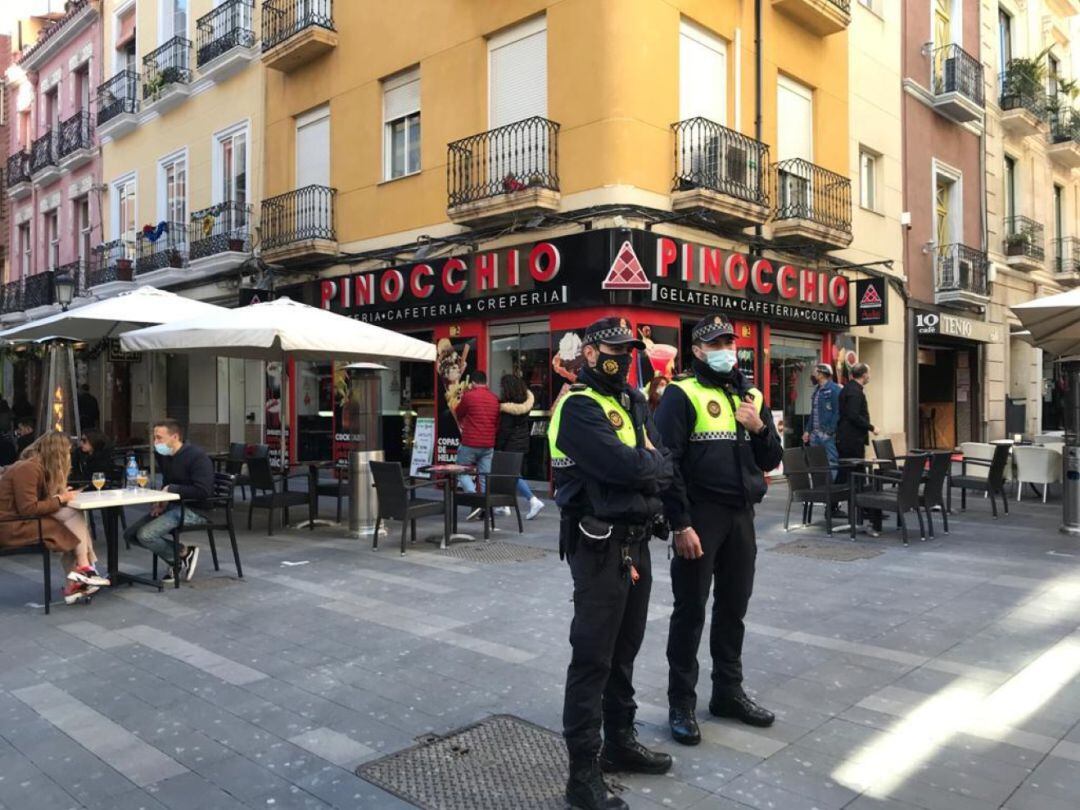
(124, 419, 214, 582)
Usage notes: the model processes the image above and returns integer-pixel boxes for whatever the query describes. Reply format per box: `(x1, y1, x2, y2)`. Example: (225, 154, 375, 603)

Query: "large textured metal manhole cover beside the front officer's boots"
(356, 715, 567, 810)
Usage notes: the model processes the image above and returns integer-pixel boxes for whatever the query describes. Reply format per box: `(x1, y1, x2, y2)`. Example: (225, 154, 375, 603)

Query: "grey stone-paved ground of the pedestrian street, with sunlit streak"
(0, 486, 1080, 810)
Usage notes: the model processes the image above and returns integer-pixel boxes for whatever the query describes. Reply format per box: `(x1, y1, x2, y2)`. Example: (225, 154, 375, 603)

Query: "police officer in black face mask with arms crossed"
(548, 318, 672, 810)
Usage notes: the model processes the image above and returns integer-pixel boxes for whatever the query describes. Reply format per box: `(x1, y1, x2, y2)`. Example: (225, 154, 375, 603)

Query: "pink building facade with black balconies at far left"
(2, 0, 103, 320)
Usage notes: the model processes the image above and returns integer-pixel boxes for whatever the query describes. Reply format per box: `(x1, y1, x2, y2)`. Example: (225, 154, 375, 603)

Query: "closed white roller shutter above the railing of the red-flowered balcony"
(488, 18, 548, 130)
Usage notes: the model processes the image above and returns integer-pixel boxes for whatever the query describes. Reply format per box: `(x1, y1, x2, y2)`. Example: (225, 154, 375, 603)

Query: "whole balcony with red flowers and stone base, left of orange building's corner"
(446, 116, 562, 225)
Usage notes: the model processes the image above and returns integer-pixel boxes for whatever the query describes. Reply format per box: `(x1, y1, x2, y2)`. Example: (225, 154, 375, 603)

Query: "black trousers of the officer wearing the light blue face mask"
(667, 503, 757, 708)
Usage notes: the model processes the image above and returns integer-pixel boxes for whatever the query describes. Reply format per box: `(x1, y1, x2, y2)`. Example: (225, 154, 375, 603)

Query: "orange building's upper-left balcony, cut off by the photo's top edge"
(262, 0, 337, 73)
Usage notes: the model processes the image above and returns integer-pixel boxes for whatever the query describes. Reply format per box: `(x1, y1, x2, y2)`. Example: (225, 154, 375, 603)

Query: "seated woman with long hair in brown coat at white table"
(0, 432, 109, 605)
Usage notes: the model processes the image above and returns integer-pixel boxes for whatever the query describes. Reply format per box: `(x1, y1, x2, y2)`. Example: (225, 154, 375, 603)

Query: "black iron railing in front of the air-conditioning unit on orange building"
(672, 118, 769, 205)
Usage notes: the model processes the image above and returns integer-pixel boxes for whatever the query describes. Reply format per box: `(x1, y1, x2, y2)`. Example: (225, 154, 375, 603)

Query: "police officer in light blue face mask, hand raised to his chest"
(656, 315, 783, 745)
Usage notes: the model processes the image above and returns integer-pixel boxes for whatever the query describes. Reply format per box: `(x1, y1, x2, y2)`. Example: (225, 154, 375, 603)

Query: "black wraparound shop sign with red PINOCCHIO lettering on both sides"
(308, 230, 848, 327)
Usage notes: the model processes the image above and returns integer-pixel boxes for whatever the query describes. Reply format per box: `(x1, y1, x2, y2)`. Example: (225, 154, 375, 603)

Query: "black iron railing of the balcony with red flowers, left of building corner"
(446, 116, 559, 207)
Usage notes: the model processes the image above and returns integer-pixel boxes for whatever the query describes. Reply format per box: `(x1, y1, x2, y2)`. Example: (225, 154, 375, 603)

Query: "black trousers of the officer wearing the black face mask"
(563, 540, 652, 758)
